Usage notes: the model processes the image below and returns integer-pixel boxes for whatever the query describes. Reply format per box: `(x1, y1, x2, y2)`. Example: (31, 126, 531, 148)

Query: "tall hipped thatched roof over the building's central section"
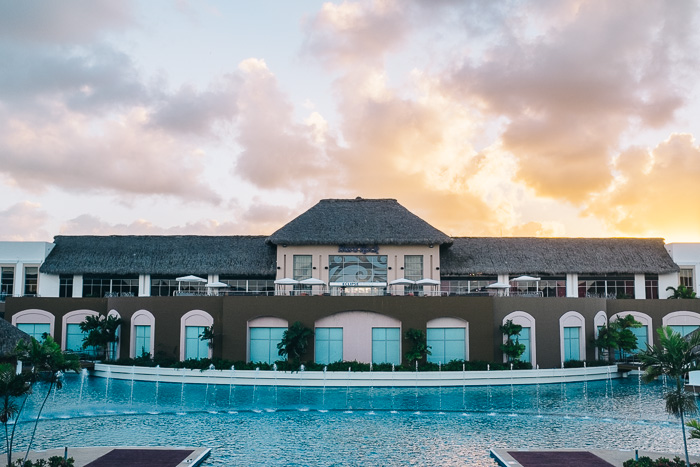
(268, 198, 452, 245)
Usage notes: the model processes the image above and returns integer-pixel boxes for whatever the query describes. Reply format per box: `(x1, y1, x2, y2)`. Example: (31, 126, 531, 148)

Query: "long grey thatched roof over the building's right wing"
(440, 237, 679, 277)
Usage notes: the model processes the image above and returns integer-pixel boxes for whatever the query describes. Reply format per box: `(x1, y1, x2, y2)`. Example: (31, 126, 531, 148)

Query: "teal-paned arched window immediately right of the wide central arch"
(426, 317, 469, 363)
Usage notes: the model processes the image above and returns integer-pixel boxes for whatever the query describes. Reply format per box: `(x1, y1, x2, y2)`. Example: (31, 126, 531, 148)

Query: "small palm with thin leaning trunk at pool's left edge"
(15, 336, 80, 462)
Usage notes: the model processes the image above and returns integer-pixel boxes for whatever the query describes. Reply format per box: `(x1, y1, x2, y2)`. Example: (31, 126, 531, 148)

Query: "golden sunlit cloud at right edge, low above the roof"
(587, 134, 700, 241)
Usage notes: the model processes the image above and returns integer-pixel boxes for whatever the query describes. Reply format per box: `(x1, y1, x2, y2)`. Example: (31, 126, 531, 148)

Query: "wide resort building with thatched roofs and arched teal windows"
(0, 198, 700, 368)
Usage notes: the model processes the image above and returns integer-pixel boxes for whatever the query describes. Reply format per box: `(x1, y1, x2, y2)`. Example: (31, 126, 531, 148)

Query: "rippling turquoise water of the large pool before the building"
(6, 375, 700, 466)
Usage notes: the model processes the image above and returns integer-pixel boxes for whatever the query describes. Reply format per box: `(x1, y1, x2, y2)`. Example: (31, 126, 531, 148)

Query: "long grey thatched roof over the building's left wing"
(41, 235, 276, 277)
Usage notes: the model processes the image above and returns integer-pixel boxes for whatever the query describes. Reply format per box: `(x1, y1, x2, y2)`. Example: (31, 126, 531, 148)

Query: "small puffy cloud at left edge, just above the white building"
(0, 201, 51, 242)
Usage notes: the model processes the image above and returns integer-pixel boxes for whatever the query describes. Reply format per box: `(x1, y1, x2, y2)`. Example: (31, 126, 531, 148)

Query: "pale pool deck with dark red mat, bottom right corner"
(491, 449, 700, 467)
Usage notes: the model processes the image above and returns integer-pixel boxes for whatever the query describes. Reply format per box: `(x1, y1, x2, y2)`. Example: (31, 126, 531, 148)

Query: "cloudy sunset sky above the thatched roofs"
(0, 0, 700, 242)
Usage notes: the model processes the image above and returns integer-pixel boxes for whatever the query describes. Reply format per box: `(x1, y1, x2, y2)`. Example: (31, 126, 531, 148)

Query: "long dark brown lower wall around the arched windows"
(5, 296, 700, 368)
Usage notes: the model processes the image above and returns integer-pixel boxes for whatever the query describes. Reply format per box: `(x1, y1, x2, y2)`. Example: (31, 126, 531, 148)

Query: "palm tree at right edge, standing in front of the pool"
(639, 326, 700, 465)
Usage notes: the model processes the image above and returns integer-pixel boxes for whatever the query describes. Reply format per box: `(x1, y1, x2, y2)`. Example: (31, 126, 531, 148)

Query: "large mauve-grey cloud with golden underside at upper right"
(446, 2, 697, 203)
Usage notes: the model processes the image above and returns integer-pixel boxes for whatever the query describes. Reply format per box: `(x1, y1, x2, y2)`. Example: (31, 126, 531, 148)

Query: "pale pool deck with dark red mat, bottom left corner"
(23, 446, 211, 467)
